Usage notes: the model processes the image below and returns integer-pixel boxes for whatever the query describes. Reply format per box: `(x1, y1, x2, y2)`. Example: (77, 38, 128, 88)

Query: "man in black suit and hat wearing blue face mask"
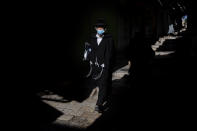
(85, 19, 115, 112)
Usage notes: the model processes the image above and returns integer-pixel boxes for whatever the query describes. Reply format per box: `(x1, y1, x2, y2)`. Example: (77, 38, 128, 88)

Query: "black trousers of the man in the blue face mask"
(88, 69, 112, 106)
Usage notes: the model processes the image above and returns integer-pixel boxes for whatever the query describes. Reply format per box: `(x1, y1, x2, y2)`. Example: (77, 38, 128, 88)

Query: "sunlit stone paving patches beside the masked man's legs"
(41, 64, 130, 129)
